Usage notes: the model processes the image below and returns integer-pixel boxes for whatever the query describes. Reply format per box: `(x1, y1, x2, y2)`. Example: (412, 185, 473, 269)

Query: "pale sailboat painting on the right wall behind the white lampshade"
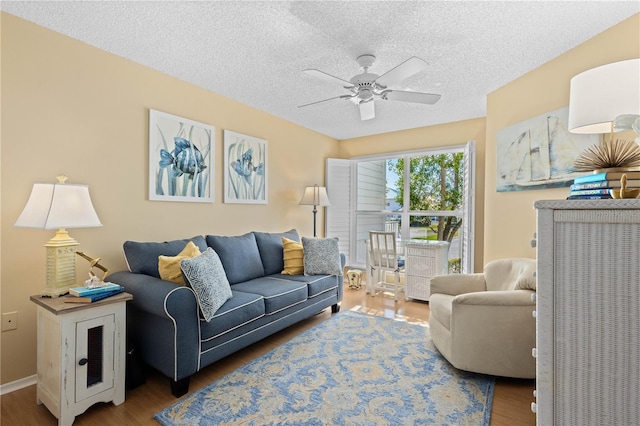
(496, 107, 601, 192)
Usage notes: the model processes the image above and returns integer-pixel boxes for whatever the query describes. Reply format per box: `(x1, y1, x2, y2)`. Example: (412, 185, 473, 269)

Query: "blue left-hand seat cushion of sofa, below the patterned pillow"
(200, 290, 264, 341)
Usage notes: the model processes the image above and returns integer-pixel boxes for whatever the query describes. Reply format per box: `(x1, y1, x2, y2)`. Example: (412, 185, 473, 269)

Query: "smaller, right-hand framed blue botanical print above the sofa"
(223, 130, 267, 204)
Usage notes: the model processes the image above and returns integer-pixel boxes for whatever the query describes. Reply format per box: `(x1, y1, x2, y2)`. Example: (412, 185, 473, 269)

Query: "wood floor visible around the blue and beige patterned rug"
(0, 288, 535, 426)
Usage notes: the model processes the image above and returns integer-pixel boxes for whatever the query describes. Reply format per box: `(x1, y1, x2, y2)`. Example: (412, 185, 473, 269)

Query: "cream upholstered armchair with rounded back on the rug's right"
(429, 259, 536, 378)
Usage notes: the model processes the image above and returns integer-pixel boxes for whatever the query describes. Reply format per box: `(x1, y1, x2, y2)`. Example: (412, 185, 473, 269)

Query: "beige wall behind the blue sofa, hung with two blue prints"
(1, 13, 339, 384)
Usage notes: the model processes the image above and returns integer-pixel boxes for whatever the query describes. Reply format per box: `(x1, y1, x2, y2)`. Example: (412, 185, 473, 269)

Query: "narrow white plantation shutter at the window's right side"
(461, 141, 476, 274)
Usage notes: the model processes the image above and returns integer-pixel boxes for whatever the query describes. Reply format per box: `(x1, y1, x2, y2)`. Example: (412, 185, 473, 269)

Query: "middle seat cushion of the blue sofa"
(232, 276, 307, 315)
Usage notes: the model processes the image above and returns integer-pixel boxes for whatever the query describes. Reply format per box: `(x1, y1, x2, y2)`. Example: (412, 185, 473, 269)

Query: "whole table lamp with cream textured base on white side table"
(14, 175, 102, 297)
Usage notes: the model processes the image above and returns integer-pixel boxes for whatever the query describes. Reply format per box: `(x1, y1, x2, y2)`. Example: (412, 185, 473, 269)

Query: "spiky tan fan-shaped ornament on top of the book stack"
(573, 139, 640, 172)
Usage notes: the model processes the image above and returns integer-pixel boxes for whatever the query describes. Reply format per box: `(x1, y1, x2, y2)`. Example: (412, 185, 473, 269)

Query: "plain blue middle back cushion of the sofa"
(206, 232, 264, 284)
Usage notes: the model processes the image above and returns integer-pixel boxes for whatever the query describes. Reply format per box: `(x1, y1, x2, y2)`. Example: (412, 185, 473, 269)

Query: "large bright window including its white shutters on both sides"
(326, 142, 474, 272)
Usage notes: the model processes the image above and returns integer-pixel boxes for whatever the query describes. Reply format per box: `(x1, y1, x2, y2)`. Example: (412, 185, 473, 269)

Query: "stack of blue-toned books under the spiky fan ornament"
(567, 171, 640, 200)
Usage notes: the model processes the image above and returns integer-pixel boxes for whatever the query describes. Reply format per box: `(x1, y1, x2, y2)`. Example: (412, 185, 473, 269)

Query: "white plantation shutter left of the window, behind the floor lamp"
(325, 158, 354, 265)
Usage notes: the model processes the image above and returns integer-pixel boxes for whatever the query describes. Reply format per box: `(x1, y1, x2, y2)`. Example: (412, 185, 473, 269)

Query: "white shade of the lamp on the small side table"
(15, 183, 102, 229)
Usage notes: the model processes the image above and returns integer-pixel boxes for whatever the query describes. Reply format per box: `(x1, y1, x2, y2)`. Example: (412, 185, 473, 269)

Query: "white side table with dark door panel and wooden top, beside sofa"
(31, 293, 133, 426)
